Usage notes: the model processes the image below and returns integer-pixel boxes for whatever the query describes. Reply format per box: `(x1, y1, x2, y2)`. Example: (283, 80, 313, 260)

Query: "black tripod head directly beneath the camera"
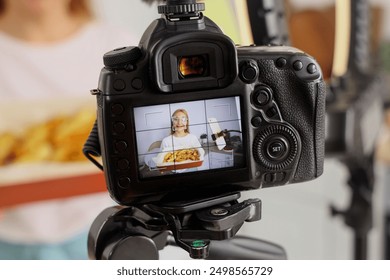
(88, 193, 287, 260)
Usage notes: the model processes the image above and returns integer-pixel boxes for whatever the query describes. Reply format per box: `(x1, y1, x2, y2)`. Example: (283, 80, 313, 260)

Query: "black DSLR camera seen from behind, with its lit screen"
(93, 1, 325, 205)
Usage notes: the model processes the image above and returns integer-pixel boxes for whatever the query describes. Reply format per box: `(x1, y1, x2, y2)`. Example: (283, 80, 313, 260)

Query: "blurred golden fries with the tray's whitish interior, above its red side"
(0, 98, 99, 186)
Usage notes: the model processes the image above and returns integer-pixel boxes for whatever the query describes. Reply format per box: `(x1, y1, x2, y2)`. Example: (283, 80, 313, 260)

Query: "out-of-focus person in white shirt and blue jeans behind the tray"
(0, 0, 138, 259)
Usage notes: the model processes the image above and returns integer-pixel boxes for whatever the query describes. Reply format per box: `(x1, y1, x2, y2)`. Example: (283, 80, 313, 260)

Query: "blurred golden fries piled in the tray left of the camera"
(0, 108, 96, 166)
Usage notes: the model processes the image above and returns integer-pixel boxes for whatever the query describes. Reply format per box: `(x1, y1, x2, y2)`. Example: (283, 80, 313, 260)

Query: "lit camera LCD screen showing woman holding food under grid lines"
(134, 97, 245, 179)
